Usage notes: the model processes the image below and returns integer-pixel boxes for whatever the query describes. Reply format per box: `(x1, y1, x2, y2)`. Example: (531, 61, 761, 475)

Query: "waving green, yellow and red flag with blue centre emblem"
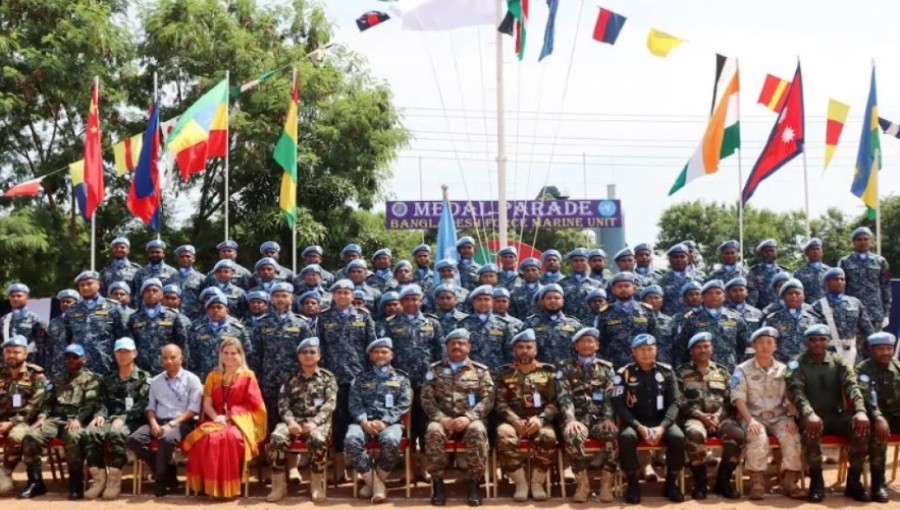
(166, 79, 228, 181)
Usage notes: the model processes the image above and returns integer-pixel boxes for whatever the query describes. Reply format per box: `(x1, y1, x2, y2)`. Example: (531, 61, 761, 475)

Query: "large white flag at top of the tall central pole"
(389, 0, 497, 32)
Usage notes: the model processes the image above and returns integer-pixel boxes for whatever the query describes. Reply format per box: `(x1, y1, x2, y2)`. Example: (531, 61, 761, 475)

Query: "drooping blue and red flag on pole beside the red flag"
(125, 99, 160, 233)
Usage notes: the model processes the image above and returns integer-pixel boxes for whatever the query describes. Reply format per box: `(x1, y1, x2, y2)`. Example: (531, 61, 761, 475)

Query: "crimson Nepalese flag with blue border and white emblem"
(742, 62, 806, 204)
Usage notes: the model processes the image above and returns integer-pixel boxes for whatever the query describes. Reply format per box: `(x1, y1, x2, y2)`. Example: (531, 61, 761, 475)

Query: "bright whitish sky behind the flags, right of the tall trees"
(312, 0, 900, 245)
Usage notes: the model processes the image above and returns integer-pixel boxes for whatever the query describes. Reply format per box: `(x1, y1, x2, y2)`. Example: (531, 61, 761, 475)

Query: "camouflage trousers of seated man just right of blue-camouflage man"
(425, 420, 488, 480)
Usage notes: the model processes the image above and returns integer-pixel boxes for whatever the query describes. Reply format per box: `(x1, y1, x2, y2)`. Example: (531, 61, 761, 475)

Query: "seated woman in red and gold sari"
(183, 338, 266, 498)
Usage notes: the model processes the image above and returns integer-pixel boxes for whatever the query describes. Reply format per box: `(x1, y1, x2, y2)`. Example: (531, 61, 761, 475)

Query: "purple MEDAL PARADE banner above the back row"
(384, 200, 622, 230)
